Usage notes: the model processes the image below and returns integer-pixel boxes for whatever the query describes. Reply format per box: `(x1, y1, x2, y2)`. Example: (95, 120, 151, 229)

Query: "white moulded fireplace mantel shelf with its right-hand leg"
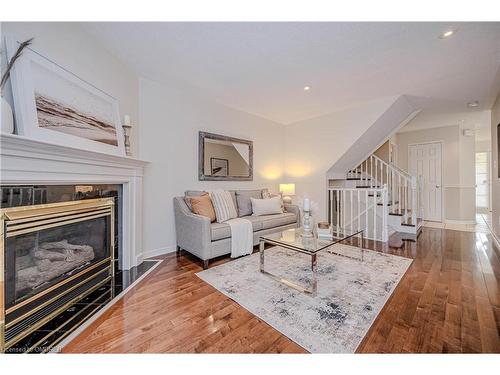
(0, 134, 148, 269)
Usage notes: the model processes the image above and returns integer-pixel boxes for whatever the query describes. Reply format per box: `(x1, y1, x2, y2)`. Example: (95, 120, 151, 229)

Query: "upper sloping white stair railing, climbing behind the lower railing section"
(347, 155, 421, 225)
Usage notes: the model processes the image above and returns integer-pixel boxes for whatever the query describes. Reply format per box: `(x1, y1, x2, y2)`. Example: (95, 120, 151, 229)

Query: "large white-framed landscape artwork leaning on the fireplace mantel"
(6, 36, 125, 156)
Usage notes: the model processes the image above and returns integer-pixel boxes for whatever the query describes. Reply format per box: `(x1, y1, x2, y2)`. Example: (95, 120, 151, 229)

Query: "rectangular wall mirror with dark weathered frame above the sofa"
(198, 132, 253, 181)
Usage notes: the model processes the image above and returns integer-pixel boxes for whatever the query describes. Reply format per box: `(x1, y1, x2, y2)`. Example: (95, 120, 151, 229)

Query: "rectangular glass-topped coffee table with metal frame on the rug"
(259, 227, 364, 295)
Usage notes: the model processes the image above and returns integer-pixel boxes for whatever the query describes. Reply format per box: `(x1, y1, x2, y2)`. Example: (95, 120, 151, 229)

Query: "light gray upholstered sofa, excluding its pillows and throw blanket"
(174, 190, 300, 269)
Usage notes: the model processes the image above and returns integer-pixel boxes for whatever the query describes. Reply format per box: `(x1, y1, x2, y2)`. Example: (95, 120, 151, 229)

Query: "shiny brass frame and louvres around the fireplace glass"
(0, 198, 115, 353)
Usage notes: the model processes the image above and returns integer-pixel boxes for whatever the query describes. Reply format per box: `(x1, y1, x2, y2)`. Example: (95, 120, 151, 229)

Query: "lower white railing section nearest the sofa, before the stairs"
(328, 186, 389, 242)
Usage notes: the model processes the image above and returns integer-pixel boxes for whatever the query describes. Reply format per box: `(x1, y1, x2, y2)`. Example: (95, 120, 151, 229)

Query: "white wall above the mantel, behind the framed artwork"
(2, 22, 139, 155)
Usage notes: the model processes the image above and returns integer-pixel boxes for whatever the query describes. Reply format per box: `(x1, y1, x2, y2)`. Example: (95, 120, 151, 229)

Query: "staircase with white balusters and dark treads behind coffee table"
(328, 155, 422, 242)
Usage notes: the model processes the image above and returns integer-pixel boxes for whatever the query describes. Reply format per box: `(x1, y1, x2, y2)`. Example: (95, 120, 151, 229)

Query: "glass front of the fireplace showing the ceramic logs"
(6, 217, 110, 308)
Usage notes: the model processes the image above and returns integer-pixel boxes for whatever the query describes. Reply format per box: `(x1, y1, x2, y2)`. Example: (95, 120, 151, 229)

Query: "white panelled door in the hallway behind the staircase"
(408, 143, 443, 221)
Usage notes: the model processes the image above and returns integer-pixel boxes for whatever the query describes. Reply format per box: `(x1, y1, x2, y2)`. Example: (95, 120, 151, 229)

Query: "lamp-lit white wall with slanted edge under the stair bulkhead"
(285, 97, 395, 220)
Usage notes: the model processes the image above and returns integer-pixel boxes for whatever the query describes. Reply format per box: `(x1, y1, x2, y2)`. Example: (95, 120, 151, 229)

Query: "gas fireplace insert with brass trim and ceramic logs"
(0, 198, 115, 351)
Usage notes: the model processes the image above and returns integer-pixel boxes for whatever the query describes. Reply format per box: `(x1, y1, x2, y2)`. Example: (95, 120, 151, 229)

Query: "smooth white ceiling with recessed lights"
(82, 22, 500, 124)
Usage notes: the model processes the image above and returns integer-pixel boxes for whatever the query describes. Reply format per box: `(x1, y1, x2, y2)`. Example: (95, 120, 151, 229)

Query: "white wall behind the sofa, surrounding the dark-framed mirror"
(139, 79, 285, 257)
